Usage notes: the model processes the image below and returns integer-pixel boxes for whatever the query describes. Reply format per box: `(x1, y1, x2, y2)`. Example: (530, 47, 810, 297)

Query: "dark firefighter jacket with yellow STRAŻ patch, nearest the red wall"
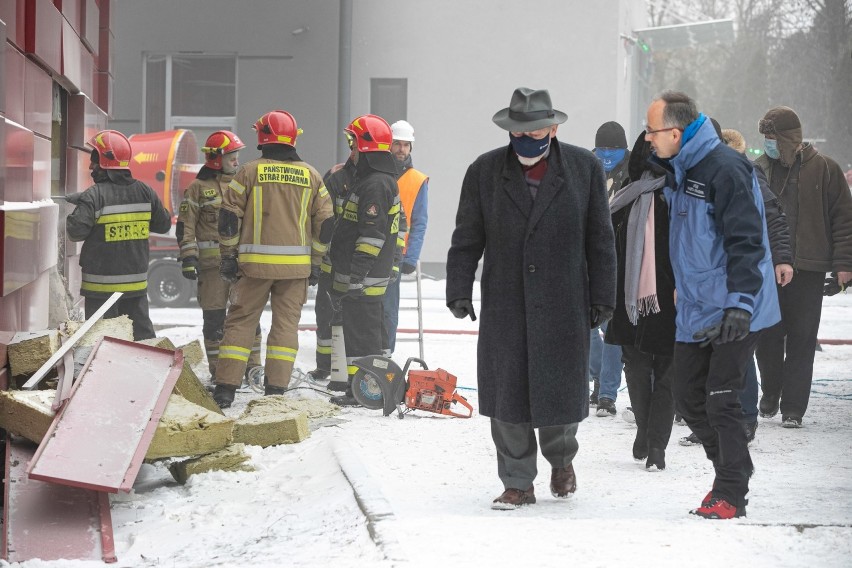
(66, 175, 172, 298)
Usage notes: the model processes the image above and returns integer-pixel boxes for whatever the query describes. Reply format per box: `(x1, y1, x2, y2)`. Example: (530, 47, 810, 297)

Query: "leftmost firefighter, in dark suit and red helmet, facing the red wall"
(65, 130, 172, 341)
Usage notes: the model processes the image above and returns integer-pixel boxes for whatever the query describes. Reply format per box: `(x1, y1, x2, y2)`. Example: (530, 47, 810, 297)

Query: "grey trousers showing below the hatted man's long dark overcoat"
(491, 418, 580, 491)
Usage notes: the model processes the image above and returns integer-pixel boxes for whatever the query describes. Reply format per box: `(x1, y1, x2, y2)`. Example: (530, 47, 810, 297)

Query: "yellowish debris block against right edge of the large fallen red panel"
(145, 394, 234, 460)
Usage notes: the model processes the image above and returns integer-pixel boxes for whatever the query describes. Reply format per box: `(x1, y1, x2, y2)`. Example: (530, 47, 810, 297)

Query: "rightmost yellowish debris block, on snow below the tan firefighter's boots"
(234, 396, 311, 447)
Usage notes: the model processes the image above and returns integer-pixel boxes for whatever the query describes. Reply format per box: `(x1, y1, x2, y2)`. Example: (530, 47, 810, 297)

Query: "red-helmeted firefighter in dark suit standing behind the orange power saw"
(329, 114, 400, 406)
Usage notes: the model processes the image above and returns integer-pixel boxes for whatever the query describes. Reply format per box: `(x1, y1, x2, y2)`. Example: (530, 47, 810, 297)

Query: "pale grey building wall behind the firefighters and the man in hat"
(110, 0, 645, 270)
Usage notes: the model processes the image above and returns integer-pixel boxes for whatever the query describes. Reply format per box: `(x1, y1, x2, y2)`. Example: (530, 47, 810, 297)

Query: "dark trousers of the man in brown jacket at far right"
(757, 270, 825, 418)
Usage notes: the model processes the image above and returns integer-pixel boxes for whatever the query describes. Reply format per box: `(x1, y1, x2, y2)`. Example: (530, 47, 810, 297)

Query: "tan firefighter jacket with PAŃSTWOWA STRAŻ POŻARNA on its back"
(219, 158, 332, 280)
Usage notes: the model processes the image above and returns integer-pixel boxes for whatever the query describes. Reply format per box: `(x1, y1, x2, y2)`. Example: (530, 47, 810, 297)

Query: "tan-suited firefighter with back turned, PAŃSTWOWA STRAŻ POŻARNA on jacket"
(213, 110, 334, 408)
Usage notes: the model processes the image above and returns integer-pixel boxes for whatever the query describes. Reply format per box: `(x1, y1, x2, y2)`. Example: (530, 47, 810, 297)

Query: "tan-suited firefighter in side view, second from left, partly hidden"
(175, 130, 261, 383)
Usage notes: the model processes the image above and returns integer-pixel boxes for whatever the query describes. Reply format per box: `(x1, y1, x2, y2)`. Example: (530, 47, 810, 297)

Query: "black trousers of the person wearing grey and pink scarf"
(621, 345, 674, 455)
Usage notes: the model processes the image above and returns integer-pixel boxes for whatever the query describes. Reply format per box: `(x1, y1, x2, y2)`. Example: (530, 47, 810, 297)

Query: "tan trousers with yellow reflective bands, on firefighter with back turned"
(216, 276, 308, 388)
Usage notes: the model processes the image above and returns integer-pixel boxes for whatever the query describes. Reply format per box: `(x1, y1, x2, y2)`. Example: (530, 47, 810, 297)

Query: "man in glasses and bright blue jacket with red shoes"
(645, 91, 781, 519)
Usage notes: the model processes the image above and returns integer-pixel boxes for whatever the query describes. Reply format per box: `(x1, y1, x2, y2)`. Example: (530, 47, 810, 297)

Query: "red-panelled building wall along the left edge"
(0, 0, 111, 331)
